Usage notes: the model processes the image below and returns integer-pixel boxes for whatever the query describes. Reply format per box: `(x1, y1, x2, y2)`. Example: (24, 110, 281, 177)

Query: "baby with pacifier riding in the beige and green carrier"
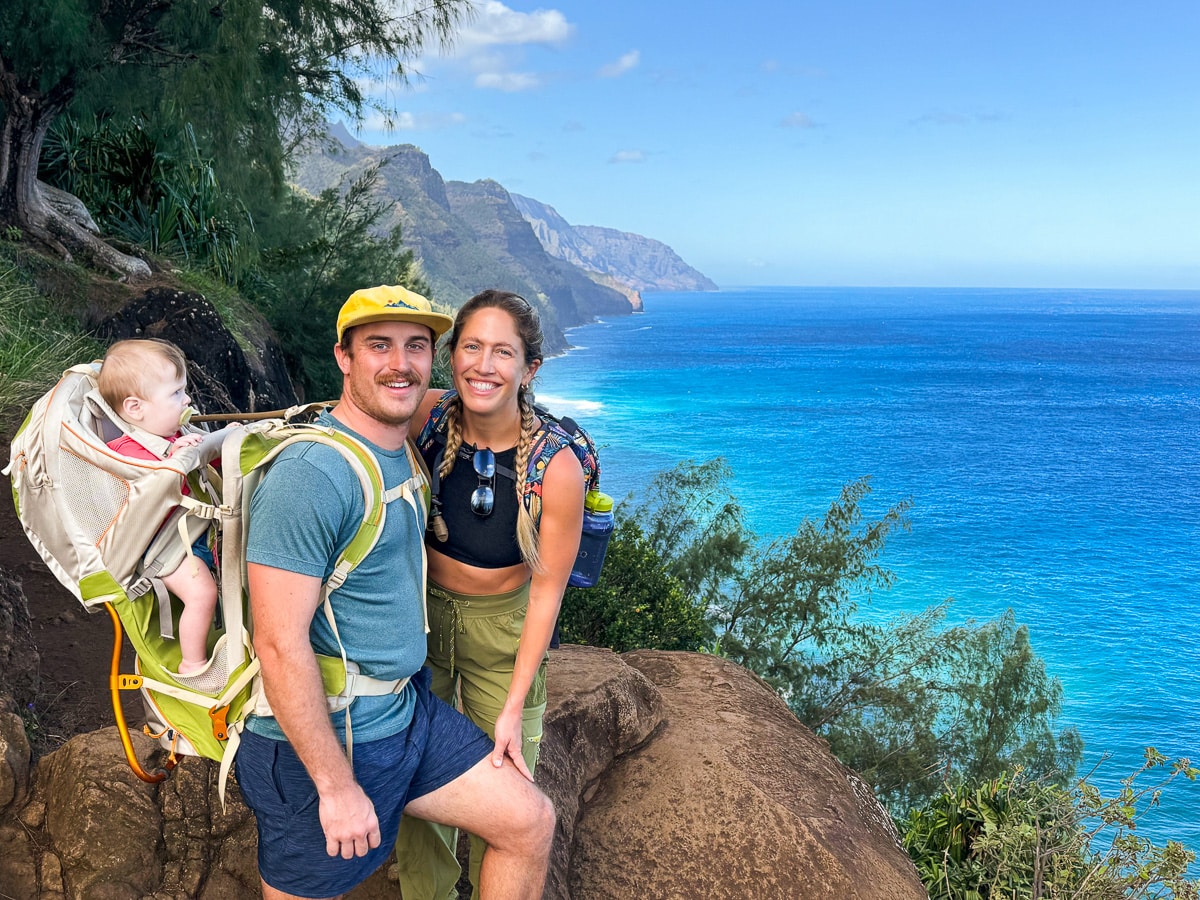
(97, 340, 217, 674)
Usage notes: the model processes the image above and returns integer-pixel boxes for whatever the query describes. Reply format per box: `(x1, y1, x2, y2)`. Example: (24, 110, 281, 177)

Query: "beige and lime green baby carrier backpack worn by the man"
(4, 362, 428, 799)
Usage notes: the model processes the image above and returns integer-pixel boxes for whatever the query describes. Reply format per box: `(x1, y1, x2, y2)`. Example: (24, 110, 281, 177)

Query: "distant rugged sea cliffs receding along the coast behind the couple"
(295, 130, 716, 353)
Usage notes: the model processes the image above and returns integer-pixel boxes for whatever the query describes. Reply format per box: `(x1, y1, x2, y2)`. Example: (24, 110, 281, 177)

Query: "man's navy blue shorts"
(236, 668, 493, 898)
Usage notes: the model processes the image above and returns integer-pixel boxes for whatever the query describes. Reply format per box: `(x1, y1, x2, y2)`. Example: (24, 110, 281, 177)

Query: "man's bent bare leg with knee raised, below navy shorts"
(404, 757, 554, 900)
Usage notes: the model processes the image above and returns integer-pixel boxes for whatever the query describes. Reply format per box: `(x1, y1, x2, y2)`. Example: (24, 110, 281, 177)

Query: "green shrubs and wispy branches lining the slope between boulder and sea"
(562, 460, 1198, 900)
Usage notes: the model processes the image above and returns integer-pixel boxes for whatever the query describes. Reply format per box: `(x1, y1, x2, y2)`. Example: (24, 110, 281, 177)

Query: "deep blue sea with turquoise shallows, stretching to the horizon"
(536, 288, 1200, 852)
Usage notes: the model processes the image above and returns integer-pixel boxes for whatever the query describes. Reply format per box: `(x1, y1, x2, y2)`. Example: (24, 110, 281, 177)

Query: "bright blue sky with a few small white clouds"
(348, 0, 1200, 289)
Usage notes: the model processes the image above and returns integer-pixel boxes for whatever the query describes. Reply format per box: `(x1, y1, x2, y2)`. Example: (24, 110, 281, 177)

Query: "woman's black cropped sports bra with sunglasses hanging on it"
(422, 444, 523, 569)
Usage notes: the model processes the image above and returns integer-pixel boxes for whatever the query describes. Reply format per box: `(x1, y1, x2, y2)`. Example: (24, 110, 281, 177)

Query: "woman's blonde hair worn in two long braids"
(439, 290, 544, 571)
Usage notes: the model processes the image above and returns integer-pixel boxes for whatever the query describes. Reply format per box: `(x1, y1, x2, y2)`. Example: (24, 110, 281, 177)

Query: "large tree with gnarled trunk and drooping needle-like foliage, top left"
(0, 0, 472, 276)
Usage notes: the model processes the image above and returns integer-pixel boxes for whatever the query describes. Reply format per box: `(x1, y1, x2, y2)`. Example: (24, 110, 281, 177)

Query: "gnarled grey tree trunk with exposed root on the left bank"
(0, 78, 150, 281)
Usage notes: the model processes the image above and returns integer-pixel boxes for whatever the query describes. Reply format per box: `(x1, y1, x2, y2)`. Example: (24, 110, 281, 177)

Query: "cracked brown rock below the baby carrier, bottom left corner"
(0, 727, 258, 900)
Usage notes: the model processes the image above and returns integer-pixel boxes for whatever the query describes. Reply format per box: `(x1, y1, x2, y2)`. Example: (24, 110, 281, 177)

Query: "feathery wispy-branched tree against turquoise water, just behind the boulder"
(590, 458, 1082, 810)
